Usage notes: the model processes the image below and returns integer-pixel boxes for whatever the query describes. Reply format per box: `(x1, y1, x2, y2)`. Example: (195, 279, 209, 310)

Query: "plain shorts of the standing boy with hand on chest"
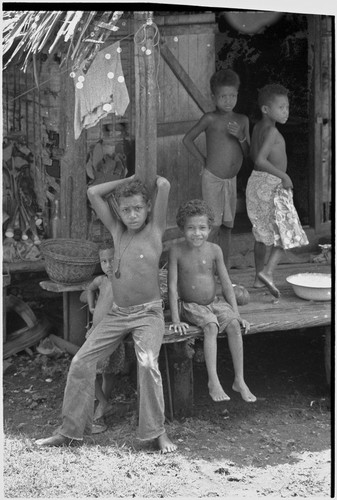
(201, 168, 237, 228)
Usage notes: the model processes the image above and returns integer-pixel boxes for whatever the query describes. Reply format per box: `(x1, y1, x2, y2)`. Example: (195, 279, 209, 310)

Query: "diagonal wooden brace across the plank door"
(160, 43, 212, 113)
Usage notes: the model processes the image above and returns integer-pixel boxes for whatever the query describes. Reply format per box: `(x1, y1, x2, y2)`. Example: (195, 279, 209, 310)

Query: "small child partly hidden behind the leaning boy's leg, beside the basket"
(86, 245, 125, 421)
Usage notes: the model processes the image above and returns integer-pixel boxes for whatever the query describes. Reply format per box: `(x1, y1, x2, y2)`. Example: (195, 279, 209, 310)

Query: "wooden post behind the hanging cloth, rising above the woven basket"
(60, 72, 88, 239)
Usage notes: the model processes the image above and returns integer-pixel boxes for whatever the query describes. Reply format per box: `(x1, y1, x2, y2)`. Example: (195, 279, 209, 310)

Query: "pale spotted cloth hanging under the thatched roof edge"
(71, 42, 130, 139)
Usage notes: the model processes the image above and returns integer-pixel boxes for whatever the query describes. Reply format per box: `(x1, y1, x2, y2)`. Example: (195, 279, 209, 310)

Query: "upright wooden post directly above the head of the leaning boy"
(134, 11, 159, 191)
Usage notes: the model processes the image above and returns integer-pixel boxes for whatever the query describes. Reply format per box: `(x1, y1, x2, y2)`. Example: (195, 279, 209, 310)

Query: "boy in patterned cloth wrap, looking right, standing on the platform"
(246, 84, 308, 298)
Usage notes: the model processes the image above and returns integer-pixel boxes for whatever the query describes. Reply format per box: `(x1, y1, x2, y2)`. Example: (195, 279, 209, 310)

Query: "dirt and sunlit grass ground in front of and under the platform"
(3, 332, 332, 498)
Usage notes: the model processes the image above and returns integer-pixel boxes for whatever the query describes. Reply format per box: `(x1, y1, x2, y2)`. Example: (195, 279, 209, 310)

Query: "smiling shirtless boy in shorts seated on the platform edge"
(168, 200, 256, 402)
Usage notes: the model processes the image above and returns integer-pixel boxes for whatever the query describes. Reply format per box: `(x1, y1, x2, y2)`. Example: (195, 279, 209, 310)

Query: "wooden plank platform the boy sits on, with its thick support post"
(162, 263, 331, 419)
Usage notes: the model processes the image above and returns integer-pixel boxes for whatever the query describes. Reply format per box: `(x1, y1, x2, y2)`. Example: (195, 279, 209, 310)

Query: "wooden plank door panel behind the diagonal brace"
(155, 14, 216, 227)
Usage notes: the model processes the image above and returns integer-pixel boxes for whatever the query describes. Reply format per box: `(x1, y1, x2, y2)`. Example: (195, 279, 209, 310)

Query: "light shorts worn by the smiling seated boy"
(181, 297, 240, 333)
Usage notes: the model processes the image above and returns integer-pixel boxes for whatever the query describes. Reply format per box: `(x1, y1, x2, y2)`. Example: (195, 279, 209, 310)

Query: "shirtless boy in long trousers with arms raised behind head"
(36, 177, 176, 453)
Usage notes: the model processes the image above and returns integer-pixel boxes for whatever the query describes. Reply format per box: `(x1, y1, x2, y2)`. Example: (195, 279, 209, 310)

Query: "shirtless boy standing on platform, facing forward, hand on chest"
(183, 69, 250, 269)
